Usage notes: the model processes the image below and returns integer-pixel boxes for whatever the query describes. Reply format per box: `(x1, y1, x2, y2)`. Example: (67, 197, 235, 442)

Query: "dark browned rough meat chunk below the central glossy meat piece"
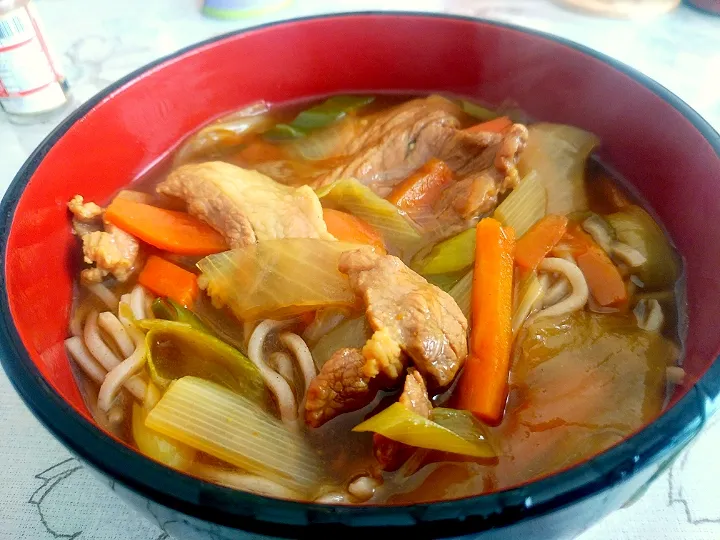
(305, 349, 378, 428)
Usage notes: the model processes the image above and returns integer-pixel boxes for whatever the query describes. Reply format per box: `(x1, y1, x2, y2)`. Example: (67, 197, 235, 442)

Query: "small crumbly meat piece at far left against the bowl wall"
(80, 223, 140, 283)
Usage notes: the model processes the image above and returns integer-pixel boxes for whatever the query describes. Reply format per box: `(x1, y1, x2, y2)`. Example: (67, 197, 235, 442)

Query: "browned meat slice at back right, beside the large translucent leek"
(435, 124, 528, 223)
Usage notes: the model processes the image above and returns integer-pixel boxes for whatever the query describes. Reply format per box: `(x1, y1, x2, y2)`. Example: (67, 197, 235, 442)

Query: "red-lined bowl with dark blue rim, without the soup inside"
(0, 14, 720, 538)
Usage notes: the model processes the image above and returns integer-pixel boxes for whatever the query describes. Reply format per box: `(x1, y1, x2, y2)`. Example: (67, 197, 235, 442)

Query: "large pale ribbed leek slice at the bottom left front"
(145, 377, 324, 495)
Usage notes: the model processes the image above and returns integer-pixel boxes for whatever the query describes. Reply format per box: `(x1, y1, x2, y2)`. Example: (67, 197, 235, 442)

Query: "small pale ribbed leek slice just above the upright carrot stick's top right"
(494, 172, 547, 238)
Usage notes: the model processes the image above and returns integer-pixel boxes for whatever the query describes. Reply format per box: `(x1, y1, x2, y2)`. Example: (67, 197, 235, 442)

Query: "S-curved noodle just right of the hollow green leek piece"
(248, 319, 298, 429)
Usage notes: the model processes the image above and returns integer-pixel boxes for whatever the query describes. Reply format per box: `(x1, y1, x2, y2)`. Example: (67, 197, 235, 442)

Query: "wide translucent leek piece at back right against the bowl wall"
(518, 124, 600, 216)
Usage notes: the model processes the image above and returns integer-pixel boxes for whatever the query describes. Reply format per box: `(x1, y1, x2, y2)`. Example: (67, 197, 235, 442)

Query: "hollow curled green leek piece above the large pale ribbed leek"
(138, 319, 269, 406)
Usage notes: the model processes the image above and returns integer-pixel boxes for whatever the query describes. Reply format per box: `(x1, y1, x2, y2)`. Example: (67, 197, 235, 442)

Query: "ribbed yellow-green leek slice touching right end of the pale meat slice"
(318, 178, 422, 260)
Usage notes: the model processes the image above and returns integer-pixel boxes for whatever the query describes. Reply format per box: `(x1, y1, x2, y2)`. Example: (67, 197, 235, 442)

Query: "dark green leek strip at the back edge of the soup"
(265, 96, 375, 140)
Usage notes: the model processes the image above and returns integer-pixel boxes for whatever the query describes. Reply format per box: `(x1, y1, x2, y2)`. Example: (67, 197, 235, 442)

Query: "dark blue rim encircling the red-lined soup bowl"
(0, 11, 720, 538)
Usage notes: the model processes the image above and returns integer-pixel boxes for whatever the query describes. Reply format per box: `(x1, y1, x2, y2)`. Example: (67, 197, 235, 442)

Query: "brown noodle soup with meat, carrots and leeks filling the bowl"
(66, 95, 683, 504)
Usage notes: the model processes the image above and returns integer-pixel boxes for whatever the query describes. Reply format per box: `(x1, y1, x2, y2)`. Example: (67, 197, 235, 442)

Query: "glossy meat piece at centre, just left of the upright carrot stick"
(338, 250, 468, 387)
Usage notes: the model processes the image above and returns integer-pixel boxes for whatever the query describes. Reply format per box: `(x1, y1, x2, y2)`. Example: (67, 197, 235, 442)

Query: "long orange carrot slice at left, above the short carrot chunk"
(105, 197, 228, 255)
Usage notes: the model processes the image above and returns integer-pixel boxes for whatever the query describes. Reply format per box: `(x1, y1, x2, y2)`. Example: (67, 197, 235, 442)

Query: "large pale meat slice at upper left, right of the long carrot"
(157, 161, 333, 247)
